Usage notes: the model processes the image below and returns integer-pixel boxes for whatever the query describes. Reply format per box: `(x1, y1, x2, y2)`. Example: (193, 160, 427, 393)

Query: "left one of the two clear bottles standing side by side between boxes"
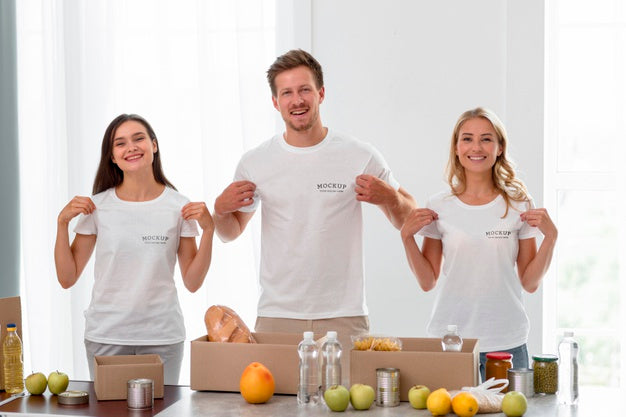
(298, 332, 320, 405)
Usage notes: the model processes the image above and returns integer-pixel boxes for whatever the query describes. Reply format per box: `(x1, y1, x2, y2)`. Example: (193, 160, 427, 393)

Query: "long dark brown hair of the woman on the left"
(92, 114, 176, 194)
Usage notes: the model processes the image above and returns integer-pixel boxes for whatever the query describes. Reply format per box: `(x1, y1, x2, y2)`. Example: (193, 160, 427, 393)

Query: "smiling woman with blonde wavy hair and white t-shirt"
(401, 107, 558, 379)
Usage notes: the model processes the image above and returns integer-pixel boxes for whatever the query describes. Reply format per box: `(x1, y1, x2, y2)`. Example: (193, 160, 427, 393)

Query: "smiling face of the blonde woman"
(455, 117, 502, 173)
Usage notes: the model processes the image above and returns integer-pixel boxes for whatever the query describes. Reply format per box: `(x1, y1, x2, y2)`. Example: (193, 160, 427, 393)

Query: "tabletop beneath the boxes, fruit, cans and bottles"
(0, 381, 624, 417)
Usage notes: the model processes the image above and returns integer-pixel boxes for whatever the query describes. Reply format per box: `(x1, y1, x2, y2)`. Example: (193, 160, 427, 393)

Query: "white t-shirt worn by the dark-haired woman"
(74, 187, 198, 345)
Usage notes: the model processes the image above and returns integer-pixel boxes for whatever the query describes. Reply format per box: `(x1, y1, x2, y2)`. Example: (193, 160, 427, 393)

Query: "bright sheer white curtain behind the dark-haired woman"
(17, 0, 276, 384)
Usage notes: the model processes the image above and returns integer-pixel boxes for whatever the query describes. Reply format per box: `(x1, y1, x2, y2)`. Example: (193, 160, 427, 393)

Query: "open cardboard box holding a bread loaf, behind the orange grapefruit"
(191, 333, 302, 394)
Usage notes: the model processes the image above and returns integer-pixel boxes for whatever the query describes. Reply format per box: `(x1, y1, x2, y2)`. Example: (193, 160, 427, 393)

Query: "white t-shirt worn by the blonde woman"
(419, 191, 540, 352)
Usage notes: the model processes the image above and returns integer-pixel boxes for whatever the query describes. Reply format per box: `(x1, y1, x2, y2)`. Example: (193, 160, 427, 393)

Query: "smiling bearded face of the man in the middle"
(272, 66, 324, 132)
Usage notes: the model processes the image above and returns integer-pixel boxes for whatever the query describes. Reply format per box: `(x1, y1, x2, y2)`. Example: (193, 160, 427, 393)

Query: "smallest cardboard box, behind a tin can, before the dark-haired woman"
(94, 354, 163, 400)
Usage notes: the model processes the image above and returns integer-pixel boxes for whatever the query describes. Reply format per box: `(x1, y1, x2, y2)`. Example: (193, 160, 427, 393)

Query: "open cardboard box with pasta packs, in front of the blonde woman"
(350, 338, 479, 401)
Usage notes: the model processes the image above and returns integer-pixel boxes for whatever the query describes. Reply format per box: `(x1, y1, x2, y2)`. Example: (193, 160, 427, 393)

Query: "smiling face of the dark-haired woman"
(111, 120, 157, 173)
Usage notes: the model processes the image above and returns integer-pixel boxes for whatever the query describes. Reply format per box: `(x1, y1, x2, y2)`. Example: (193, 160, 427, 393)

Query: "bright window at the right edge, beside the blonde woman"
(544, 0, 626, 388)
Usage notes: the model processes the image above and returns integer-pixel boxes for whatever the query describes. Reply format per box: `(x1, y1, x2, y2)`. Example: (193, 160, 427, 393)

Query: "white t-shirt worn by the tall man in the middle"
(235, 130, 399, 320)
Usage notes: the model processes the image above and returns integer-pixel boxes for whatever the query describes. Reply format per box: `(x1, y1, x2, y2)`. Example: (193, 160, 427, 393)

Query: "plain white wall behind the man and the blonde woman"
(277, 0, 544, 354)
